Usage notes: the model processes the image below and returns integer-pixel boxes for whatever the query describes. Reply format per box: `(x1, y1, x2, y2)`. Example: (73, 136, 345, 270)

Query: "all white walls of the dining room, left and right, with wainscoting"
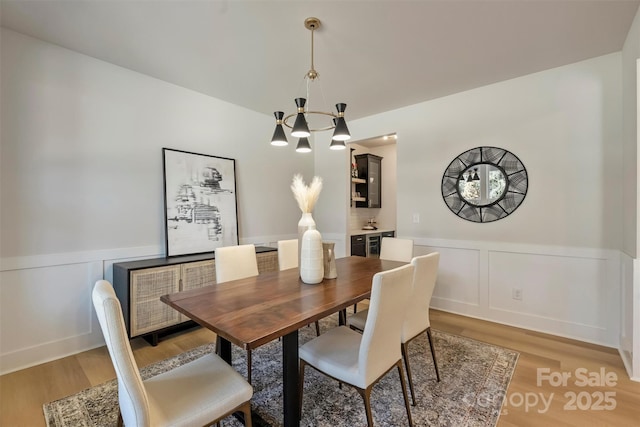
(0, 26, 623, 372)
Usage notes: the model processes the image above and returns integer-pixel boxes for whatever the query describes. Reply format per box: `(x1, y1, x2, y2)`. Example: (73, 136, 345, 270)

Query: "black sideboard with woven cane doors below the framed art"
(113, 246, 278, 345)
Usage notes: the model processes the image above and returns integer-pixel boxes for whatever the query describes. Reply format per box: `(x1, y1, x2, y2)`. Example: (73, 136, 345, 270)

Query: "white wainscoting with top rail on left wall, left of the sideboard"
(0, 247, 159, 375)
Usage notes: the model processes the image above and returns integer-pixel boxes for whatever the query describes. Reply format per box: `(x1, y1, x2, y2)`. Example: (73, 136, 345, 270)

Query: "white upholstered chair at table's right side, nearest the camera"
(299, 264, 414, 426)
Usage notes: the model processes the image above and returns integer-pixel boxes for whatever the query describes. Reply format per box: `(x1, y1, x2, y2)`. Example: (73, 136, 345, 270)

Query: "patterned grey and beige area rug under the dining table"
(43, 318, 518, 427)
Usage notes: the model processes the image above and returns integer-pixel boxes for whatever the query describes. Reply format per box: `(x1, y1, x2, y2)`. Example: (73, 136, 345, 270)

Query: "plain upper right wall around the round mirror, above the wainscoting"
(398, 54, 622, 249)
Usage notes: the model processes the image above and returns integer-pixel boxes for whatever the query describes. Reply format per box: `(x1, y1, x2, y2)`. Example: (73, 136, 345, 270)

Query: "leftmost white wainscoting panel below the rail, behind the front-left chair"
(0, 262, 103, 373)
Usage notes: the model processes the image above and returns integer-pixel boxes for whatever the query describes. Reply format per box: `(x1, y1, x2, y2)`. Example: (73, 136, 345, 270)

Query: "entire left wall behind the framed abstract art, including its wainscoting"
(0, 29, 312, 372)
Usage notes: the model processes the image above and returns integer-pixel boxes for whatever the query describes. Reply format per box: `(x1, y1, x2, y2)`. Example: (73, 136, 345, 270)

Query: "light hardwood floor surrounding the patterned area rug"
(0, 310, 640, 427)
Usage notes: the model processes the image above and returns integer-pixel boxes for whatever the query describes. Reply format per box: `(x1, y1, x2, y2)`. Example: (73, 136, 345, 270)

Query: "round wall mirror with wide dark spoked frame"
(442, 147, 529, 222)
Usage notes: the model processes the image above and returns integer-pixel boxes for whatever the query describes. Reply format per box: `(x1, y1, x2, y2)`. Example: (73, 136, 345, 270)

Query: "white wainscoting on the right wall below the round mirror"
(414, 238, 621, 348)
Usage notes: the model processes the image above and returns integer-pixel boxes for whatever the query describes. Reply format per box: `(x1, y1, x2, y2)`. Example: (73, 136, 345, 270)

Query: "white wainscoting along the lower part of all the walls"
(0, 239, 620, 374)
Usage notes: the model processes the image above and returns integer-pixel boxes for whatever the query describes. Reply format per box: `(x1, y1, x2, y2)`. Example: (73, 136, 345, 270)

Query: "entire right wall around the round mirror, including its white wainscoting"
(330, 53, 622, 347)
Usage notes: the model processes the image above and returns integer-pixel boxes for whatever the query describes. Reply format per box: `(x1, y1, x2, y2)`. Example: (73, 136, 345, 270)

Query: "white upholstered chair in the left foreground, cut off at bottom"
(92, 280, 253, 427)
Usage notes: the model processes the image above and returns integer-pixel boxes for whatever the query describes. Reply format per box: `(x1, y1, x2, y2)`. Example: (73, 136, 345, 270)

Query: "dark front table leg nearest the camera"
(282, 330, 300, 427)
